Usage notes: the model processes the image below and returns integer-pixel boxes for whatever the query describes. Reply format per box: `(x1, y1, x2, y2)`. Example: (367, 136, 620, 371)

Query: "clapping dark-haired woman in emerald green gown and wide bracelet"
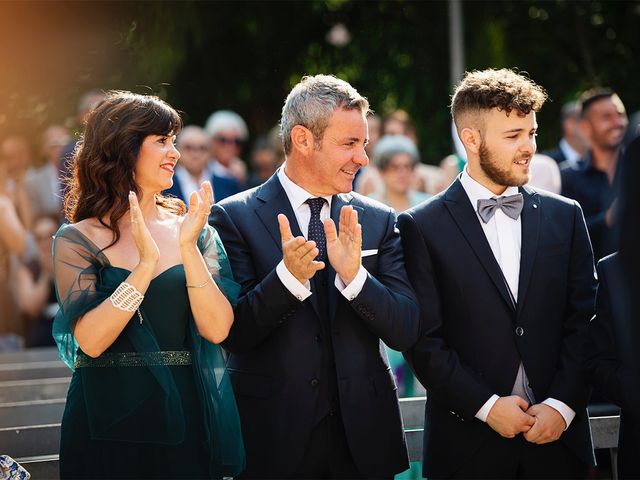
(53, 91, 244, 479)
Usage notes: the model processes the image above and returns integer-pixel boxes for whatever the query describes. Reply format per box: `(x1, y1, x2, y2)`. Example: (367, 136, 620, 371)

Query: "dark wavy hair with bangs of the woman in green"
(64, 90, 186, 248)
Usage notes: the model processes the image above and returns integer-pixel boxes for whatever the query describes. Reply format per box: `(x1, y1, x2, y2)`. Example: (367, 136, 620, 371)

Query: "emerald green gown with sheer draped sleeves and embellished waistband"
(54, 225, 244, 479)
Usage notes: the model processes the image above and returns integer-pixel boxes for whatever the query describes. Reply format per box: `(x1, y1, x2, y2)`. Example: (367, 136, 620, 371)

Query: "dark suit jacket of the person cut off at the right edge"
(587, 253, 640, 478)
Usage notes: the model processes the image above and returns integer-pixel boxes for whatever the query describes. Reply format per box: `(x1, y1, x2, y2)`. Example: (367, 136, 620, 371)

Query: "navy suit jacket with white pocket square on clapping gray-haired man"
(212, 175, 419, 478)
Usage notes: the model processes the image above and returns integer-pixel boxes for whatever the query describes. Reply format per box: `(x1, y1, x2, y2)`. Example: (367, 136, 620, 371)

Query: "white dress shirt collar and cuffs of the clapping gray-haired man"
(276, 163, 367, 301)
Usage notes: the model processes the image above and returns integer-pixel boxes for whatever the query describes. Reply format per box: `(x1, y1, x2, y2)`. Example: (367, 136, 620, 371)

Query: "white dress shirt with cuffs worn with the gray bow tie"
(460, 167, 576, 428)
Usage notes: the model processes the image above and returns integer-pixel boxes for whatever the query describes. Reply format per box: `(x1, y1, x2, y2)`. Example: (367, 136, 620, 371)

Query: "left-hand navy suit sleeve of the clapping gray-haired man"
(210, 205, 303, 353)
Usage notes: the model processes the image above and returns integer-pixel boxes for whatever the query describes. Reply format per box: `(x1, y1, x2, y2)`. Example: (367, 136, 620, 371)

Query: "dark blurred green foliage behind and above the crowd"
(0, 0, 640, 163)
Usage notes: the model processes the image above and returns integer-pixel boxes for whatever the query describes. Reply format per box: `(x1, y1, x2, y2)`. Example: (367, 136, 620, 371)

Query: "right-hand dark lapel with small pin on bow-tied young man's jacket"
(518, 186, 541, 314)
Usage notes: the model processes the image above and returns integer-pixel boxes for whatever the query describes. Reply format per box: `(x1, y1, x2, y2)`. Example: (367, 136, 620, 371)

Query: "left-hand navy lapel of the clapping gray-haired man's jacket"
(256, 173, 302, 252)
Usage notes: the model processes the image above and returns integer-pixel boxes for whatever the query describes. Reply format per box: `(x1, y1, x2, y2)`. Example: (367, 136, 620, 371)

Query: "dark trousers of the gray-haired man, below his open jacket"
(291, 413, 363, 478)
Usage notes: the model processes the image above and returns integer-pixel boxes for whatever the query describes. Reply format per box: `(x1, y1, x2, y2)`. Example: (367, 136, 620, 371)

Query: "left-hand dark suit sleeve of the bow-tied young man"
(398, 213, 495, 420)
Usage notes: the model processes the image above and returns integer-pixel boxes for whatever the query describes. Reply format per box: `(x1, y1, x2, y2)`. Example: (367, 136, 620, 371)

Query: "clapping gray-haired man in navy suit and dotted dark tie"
(212, 75, 419, 478)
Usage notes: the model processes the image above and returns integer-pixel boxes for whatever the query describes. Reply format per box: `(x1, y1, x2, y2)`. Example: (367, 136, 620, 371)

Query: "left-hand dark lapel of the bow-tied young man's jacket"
(444, 179, 516, 310)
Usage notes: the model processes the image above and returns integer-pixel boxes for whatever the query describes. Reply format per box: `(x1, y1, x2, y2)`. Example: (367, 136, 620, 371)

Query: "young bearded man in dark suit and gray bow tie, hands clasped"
(398, 69, 595, 478)
